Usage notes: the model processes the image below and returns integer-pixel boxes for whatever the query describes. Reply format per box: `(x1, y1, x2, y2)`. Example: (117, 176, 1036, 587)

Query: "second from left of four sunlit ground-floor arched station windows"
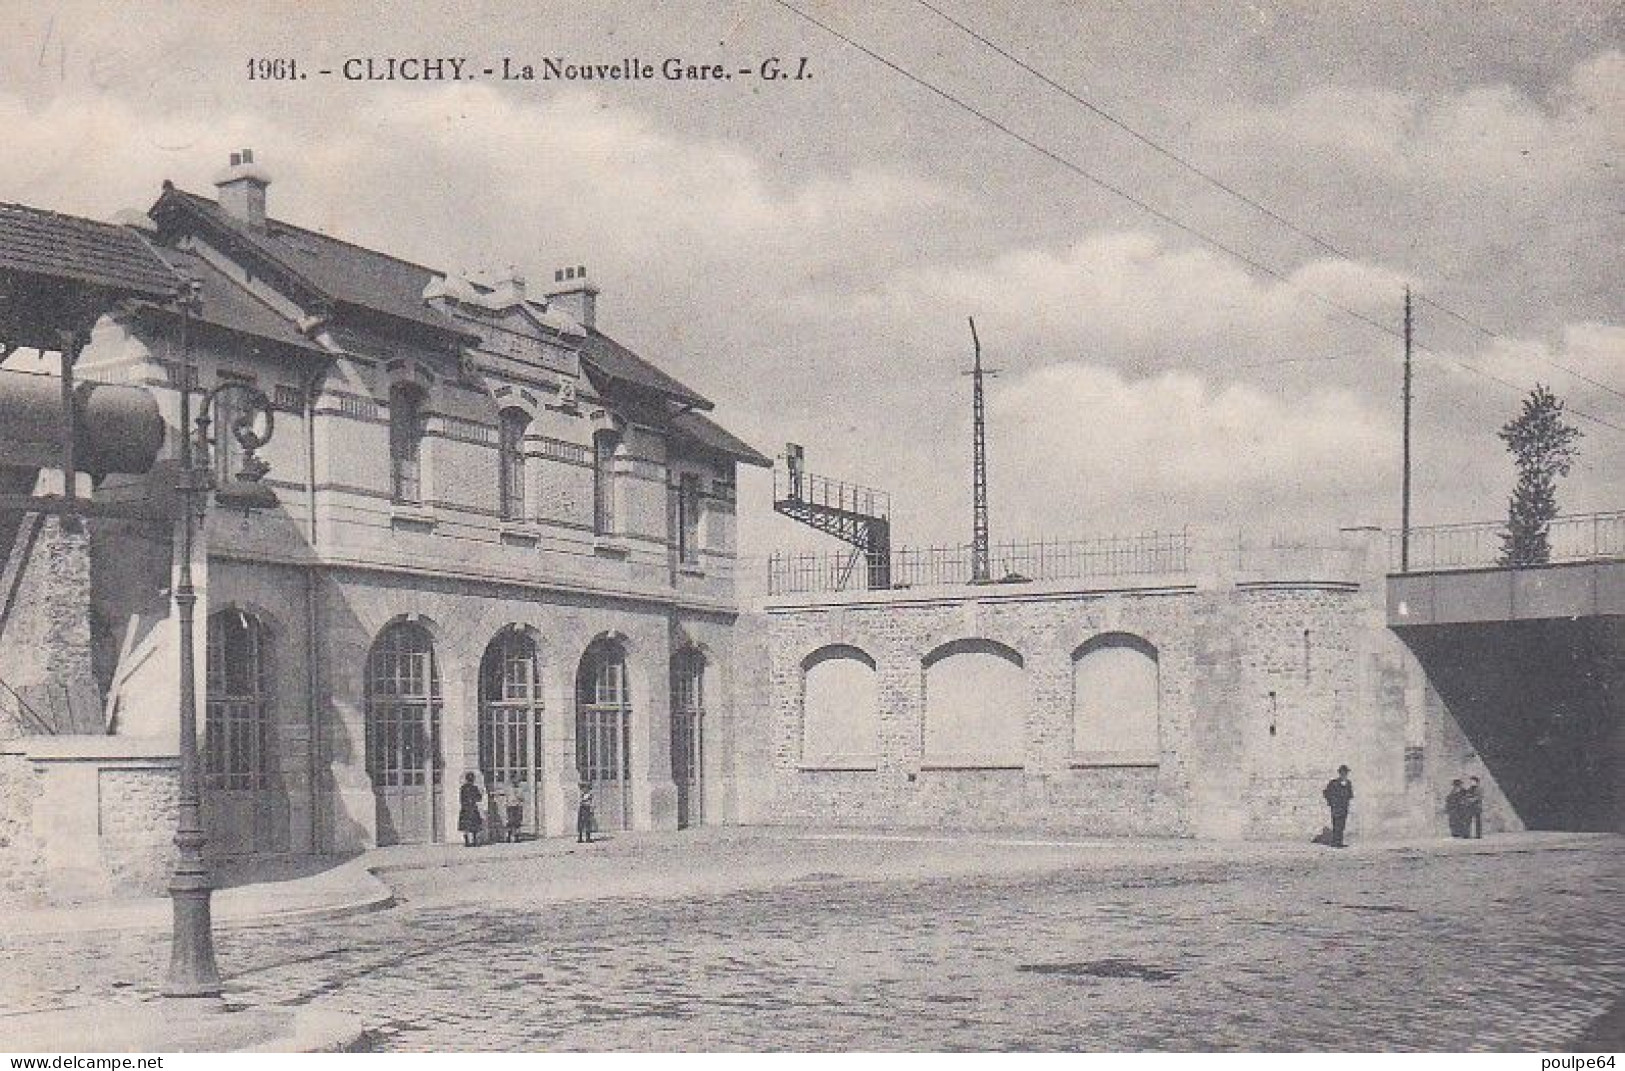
(479, 629, 541, 787)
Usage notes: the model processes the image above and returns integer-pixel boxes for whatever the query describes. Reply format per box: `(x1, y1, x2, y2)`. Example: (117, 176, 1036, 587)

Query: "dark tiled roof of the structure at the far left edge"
(0, 203, 180, 299)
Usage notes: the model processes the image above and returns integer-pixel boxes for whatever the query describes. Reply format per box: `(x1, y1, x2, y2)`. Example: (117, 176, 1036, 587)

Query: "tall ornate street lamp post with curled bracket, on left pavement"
(163, 283, 276, 996)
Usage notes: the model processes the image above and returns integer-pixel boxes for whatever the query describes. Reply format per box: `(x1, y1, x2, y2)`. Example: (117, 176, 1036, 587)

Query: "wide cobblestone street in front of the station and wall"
(0, 832, 1625, 1050)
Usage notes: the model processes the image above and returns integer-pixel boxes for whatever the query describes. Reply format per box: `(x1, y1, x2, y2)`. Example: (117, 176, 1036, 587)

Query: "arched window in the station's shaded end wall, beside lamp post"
(203, 609, 271, 790)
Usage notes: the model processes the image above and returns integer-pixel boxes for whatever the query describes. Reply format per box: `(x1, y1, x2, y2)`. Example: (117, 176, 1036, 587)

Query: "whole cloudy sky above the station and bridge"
(0, 0, 1625, 556)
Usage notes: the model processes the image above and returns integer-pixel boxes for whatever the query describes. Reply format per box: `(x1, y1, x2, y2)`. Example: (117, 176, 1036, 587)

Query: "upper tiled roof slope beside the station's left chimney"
(153, 189, 470, 338)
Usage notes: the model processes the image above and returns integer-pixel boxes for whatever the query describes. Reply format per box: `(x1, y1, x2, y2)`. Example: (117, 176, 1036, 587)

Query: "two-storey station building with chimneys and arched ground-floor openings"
(0, 151, 767, 903)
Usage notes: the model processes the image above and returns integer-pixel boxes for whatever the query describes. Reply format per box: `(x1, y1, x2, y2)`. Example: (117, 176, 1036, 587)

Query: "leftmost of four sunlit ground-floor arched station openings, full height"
(367, 621, 442, 843)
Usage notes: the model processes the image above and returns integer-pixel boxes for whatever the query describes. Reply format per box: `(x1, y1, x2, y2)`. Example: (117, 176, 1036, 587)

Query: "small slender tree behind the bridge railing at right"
(1500, 384, 1580, 566)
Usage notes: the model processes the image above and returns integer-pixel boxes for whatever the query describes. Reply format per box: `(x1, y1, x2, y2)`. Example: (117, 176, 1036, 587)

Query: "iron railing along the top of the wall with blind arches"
(767, 531, 1190, 595)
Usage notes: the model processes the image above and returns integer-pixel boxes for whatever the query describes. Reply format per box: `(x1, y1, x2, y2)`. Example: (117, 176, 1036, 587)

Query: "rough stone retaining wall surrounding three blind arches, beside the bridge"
(741, 533, 1495, 840)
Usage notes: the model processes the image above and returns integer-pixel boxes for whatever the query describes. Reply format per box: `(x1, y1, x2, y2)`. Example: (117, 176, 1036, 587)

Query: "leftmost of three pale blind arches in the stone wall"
(801, 644, 881, 770)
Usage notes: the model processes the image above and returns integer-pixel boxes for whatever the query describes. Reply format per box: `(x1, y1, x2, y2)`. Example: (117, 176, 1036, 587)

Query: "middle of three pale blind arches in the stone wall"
(923, 639, 1032, 767)
